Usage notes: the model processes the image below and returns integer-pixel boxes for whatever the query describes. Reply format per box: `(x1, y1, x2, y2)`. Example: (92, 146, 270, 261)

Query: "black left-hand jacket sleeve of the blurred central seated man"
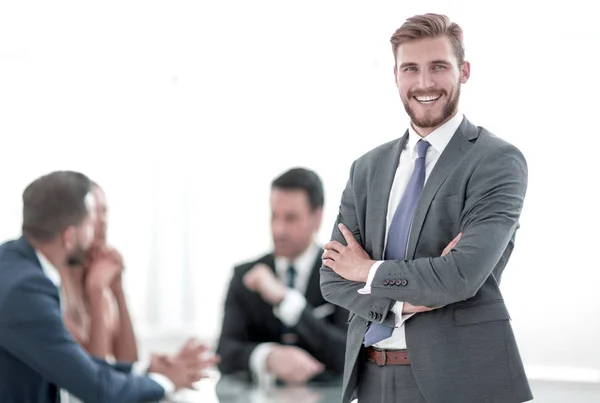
(217, 269, 259, 374)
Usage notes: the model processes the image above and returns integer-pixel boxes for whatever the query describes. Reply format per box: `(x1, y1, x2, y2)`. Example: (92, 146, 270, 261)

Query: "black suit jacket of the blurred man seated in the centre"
(217, 251, 348, 376)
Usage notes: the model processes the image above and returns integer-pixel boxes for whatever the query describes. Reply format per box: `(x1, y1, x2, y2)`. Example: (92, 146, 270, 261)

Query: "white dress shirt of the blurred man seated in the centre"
(249, 243, 321, 384)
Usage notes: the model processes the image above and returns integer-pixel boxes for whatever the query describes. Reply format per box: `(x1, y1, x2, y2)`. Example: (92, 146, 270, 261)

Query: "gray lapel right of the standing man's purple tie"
(406, 117, 479, 259)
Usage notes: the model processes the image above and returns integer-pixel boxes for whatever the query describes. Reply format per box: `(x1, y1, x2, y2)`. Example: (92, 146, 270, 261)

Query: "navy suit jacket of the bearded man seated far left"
(0, 238, 164, 403)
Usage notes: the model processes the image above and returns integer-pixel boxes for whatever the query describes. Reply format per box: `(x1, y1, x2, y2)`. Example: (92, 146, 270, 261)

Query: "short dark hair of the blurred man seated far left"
(23, 171, 91, 242)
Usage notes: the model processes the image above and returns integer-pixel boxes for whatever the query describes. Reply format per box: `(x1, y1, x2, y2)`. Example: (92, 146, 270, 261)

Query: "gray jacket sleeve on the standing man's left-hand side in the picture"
(321, 164, 396, 326)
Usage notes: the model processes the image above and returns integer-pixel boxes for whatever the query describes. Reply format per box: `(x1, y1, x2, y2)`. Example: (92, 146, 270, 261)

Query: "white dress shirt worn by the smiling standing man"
(358, 113, 463, 350)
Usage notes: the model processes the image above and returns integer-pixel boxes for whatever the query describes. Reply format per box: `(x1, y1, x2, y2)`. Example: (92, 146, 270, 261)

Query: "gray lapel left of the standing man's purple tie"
(367, 130, 408, 260)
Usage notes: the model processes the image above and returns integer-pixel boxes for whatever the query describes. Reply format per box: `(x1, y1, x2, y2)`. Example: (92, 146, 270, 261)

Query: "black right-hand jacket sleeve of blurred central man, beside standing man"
(295, 305, 348, 374)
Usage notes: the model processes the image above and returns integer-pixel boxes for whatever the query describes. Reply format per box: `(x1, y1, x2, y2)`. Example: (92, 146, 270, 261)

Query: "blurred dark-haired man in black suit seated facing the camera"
(217, 168, 348, 384)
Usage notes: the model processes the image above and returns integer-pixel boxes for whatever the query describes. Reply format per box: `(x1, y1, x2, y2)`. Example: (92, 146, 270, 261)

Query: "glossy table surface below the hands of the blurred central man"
(169, 375, 342, 403)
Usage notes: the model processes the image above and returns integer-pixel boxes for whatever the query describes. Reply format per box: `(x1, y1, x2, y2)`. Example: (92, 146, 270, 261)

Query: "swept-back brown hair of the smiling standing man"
(390, 13, 465, 66)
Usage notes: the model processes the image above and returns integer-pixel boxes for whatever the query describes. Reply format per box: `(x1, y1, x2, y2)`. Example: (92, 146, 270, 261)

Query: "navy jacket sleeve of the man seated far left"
(0, 277, 165, 403)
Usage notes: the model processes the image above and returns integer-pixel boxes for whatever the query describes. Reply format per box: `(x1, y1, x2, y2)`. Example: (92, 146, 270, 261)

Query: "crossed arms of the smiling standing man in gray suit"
(321, 146, 527, 322)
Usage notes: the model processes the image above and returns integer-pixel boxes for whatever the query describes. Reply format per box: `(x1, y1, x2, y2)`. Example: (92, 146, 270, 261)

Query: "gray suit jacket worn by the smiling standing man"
(321, 118, 532, 403)
